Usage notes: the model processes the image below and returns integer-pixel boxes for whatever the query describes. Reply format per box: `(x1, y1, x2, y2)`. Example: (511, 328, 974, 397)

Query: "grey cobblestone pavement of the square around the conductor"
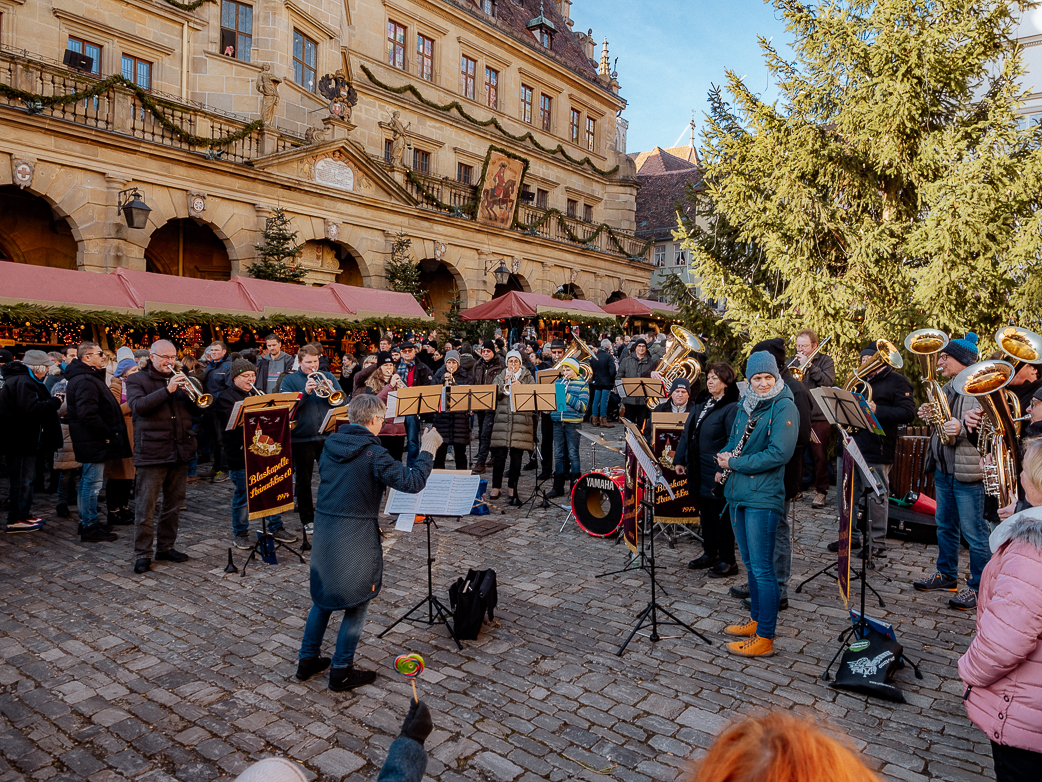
(0, 442, 993, 782)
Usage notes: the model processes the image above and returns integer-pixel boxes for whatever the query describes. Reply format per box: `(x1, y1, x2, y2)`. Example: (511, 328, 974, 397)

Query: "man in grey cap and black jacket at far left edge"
(0, 350, 63, 533)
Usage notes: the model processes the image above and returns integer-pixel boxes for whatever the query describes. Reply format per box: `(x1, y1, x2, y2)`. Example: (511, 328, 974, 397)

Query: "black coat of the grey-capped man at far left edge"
(0, 361, 65, 457)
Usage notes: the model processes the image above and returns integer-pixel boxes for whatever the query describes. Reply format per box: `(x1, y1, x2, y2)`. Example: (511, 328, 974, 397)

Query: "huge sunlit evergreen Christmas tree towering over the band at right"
(677, 0, 1042, 375)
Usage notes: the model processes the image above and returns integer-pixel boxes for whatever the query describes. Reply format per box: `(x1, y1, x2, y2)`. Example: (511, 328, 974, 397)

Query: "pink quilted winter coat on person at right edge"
(959, 508, 1042, 752)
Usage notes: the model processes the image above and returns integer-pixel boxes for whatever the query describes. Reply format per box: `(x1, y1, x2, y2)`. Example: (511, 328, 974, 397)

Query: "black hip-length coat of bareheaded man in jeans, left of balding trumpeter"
(66, 359, 132, 464)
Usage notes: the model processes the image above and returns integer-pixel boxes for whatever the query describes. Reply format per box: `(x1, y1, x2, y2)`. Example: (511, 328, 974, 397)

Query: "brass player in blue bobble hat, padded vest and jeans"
(912, 332, 991, 611)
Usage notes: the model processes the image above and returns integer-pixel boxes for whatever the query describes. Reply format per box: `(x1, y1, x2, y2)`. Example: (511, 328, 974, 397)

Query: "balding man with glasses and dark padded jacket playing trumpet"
(127, 340, 196, 573)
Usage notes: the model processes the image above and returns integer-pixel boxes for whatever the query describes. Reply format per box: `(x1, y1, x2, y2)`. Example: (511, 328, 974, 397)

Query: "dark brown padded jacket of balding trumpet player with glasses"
(127, 362, 196, 467)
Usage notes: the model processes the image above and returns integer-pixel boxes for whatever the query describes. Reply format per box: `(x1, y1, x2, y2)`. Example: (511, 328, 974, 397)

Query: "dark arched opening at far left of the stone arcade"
(0, 185, 83, 269)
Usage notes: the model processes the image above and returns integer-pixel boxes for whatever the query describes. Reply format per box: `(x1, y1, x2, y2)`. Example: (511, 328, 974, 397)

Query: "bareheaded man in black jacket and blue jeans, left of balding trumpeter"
(66, 342, 131, 543)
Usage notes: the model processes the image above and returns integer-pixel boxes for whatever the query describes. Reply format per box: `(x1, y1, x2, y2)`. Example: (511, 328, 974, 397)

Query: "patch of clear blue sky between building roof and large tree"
(571, 0, 788, 152)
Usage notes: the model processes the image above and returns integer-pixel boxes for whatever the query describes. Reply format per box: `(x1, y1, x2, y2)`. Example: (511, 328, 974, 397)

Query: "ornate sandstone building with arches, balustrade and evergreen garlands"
(0, 0, 652, 316)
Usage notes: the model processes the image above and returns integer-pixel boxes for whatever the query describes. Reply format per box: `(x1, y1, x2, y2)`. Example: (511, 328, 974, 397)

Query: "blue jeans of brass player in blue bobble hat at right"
(934, 470, 991, 592)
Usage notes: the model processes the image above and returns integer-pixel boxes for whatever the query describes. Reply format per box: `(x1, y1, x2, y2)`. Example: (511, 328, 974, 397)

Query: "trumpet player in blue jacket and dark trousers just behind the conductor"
(281, 345, 343, 538)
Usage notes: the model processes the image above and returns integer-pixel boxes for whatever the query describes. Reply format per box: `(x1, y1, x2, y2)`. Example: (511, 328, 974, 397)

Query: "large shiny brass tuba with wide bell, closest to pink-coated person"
(954, 361, 1020, 508)
